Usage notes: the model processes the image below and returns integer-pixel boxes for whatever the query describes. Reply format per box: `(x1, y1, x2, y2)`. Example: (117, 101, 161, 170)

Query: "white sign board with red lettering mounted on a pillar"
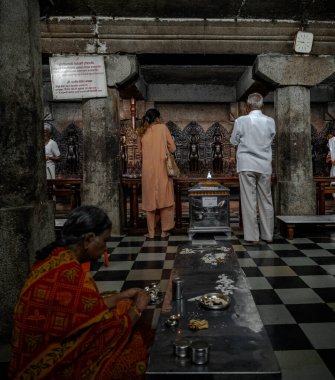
(50, 56, 107, 100)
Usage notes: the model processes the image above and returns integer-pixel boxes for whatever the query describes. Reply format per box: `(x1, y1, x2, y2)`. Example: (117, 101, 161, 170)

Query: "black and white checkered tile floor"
(0, 226, 335, 380)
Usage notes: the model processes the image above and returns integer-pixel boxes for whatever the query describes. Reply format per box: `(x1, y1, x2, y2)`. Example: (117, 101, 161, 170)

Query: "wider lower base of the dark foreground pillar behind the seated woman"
(0, 201, 55, 341)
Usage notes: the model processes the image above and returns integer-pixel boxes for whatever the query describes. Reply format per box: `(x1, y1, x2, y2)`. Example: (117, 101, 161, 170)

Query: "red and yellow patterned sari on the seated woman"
(9, 248, 147, 380)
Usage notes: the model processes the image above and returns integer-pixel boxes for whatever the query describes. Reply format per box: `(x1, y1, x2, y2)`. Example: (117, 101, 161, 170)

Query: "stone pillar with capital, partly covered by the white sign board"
(82, 55, 139, 235)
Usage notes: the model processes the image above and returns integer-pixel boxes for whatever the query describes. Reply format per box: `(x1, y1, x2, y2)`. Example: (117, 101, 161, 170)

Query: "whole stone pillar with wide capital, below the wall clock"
(253, 54, 335, 215)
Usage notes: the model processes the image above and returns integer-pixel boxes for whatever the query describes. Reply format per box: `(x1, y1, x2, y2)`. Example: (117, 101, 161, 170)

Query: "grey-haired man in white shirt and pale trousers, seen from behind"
(230, 93, 276, 243)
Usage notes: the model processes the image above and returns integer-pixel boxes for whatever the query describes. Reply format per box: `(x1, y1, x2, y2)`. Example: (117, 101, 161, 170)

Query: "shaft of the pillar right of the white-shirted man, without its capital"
(275, 86, 316, 215)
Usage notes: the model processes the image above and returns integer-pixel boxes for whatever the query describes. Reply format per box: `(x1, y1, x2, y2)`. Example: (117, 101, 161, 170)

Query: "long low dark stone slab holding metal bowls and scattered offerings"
(146, 246, 281, 380)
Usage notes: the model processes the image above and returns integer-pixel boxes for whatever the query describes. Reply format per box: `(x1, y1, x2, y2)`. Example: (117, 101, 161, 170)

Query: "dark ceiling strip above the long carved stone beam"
(40, 0, 335, 22)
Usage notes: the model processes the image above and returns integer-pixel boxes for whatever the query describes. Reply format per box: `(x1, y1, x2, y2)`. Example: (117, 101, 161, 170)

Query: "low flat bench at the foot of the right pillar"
(277, 215, 335, 240)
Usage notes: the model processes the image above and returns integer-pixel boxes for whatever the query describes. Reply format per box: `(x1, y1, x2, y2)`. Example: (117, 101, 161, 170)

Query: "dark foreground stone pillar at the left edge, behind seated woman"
(0, 0, 54, 341)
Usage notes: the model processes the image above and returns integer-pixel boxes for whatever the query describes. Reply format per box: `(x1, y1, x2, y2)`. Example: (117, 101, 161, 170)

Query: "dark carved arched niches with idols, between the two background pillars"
(120, 120, 236, 177)
